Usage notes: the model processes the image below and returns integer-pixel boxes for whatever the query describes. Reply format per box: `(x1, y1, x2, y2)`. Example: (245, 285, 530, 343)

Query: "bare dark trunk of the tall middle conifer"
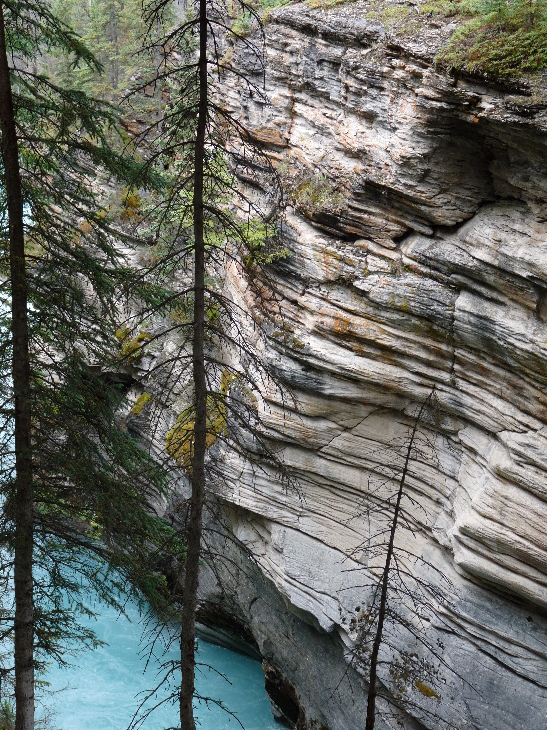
(179, 0, 208, 730)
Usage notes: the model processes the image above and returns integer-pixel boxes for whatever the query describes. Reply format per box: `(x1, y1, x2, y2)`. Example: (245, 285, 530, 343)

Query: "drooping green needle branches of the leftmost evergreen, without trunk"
(0, 0, 178, 684)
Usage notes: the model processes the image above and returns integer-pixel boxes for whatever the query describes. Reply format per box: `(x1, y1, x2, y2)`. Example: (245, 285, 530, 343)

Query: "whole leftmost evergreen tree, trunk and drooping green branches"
(0, 0, 180, 730)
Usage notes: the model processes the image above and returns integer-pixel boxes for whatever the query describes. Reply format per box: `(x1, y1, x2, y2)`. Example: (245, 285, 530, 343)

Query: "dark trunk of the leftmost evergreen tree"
(0, 1, 34, 730)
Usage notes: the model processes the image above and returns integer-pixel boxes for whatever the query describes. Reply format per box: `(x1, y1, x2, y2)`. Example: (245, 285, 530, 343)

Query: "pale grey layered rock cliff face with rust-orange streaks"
(200, 4, 547, 730)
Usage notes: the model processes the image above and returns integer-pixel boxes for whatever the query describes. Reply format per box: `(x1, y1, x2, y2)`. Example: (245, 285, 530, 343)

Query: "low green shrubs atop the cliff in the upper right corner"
(437, 0, 547, 77)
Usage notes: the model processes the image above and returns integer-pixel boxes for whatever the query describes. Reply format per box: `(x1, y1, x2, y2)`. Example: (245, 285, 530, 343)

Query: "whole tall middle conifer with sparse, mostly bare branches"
(122, 0, 286, 730)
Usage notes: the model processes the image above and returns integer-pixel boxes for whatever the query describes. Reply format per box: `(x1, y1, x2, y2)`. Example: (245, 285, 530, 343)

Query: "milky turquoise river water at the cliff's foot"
(43, 592, 279, 730)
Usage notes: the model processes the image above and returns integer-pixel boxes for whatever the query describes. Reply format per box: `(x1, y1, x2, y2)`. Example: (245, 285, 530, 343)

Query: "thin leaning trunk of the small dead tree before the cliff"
(365, 391, 433, 730)
